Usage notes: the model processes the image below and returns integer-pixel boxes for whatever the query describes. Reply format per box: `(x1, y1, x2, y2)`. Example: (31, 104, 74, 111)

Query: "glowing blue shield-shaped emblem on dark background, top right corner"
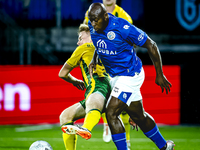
(176, 0, 200, 31)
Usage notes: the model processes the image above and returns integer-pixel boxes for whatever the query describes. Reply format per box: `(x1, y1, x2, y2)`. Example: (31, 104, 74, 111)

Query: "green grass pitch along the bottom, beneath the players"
(0, 125, 200, 150)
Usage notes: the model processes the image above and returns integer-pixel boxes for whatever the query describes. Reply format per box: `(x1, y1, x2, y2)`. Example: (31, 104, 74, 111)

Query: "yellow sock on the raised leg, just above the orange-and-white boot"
(83, 109, 101, 131)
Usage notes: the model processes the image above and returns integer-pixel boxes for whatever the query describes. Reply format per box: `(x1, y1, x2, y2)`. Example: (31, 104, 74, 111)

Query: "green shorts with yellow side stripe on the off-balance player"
(80, 75, 111, 112)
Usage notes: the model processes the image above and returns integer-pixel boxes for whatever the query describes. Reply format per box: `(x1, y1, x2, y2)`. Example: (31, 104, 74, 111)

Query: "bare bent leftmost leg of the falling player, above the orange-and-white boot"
(60, 102, 85, 125)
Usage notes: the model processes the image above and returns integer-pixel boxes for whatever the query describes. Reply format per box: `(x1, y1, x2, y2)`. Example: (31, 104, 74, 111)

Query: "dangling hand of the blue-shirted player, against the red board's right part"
(156, 75, 172, 94)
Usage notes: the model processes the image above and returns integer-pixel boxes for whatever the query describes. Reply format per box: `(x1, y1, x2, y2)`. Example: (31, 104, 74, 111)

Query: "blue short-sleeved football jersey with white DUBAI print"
(88, 13, 147, 77)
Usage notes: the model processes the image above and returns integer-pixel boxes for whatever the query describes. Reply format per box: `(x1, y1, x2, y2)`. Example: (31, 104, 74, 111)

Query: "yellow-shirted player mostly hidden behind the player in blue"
(84, 0, 133, 149)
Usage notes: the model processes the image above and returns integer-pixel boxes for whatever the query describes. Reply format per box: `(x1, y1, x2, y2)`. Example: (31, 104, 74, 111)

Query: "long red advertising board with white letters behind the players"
(0, 65, 180, 125)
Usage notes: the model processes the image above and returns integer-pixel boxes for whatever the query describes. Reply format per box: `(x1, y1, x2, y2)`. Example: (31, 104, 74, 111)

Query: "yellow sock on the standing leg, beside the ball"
(63, 133, 77, 150)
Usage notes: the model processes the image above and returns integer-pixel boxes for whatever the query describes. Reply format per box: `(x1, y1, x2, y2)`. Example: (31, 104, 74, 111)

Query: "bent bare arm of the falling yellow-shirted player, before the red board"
(58, 63, 85, 90)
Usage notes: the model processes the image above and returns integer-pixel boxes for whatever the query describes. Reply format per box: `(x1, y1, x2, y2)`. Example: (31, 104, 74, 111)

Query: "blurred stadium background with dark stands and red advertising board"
(0, 0, 200, 125)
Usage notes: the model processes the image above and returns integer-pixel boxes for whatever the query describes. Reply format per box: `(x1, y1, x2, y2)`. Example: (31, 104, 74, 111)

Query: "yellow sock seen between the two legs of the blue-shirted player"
(120, 112, 131, 141)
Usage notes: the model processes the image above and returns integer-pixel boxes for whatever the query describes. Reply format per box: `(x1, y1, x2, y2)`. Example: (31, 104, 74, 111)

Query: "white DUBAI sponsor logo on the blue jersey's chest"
(97, 39, 117, 55)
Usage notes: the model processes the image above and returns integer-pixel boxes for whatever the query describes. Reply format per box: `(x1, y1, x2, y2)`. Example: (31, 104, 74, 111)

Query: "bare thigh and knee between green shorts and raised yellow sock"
(86, 92, 105, 113)
